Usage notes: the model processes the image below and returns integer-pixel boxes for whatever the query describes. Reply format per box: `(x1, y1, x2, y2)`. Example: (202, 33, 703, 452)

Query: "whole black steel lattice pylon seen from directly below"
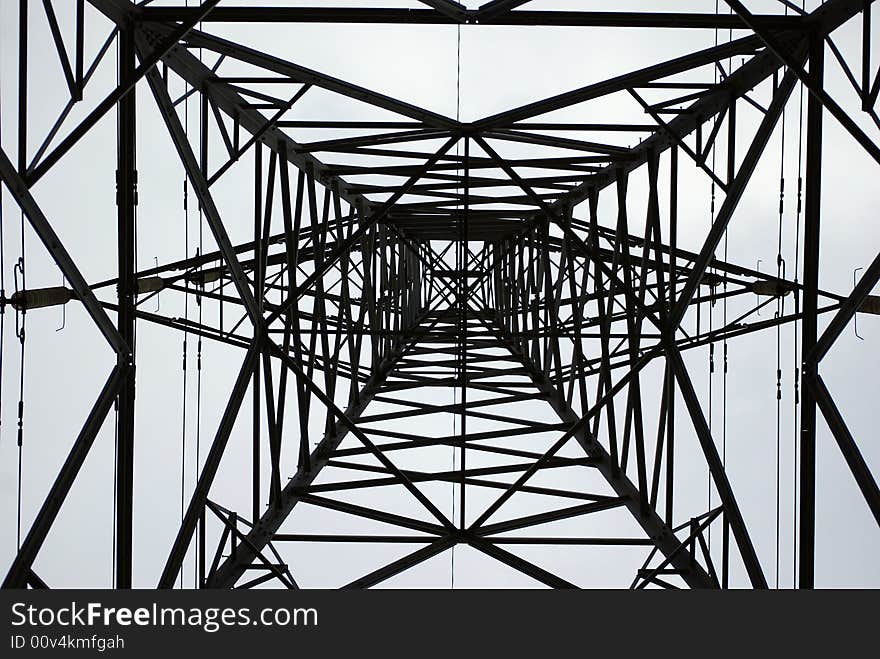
(0, 0, 880, 588)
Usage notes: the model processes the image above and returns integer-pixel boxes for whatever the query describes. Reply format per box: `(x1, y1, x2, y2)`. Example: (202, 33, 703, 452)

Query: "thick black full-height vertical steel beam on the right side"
(799, 36, 825, 588)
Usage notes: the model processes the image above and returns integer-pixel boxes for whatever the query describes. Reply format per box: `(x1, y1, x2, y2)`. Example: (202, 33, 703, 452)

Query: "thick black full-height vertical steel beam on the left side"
(115, 27, 137, 588)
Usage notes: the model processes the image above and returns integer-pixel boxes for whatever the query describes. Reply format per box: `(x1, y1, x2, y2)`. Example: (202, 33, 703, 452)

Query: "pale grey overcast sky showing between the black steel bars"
(0, 0, 880, 588)
